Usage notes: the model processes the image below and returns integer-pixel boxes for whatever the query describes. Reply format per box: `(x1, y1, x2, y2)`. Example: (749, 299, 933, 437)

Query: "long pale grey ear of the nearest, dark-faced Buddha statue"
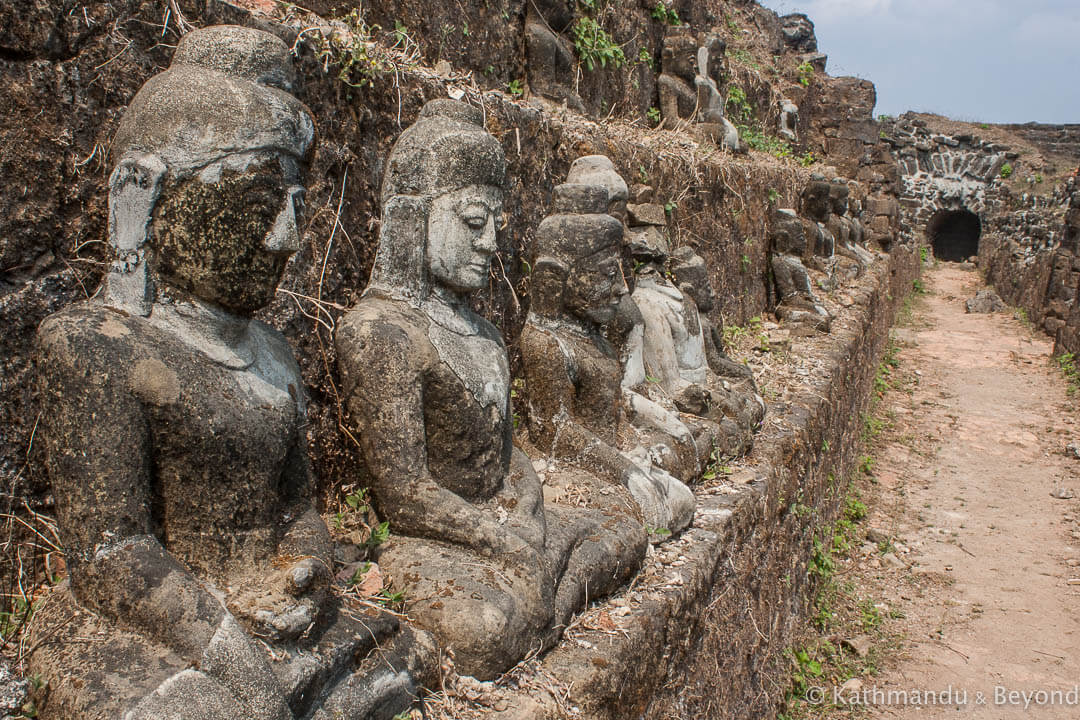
(104, 153, 165, 315)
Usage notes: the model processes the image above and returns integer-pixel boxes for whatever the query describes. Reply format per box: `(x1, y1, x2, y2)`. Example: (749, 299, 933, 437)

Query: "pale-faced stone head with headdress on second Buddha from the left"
(369, 100, 505, 302)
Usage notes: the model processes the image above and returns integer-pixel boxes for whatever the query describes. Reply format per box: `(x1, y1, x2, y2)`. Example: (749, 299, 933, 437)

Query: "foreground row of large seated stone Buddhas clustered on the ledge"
(31, 27, 765, 719)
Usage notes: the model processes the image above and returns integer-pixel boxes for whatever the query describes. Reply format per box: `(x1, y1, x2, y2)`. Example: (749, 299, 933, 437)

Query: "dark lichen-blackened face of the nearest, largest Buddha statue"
(151, 152, 303, 314)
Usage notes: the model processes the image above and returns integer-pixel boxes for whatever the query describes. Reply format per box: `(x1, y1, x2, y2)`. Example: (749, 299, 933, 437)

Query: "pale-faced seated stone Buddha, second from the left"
(335, 100, 646, 679)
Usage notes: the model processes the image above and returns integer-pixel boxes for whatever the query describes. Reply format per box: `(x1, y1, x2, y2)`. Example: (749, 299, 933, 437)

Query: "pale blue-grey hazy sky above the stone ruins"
(759, 0, 1080, 123)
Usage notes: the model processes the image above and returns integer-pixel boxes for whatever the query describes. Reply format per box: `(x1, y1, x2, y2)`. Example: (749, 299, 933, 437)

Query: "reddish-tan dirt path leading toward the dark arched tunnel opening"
(854, 263, 1080, 720)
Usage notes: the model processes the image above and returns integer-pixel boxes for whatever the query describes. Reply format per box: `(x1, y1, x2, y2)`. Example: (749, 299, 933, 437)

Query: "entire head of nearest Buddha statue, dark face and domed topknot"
(105, 26, 314, 315)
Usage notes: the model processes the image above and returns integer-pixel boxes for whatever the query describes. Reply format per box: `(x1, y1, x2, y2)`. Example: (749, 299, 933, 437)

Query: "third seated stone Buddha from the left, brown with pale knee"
(521, 167, 694, 531)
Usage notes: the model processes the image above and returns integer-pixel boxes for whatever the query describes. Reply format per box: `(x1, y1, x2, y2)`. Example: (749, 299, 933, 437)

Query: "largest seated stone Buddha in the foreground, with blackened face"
(30, 27, 433, 720)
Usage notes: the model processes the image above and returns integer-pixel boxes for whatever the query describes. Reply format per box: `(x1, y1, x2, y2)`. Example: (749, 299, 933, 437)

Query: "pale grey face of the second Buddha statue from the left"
(427, 185, 502, 291)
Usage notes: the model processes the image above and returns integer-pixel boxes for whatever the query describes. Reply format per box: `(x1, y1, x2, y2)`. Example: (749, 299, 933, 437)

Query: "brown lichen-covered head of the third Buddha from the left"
(532, 184, 626, 325)
